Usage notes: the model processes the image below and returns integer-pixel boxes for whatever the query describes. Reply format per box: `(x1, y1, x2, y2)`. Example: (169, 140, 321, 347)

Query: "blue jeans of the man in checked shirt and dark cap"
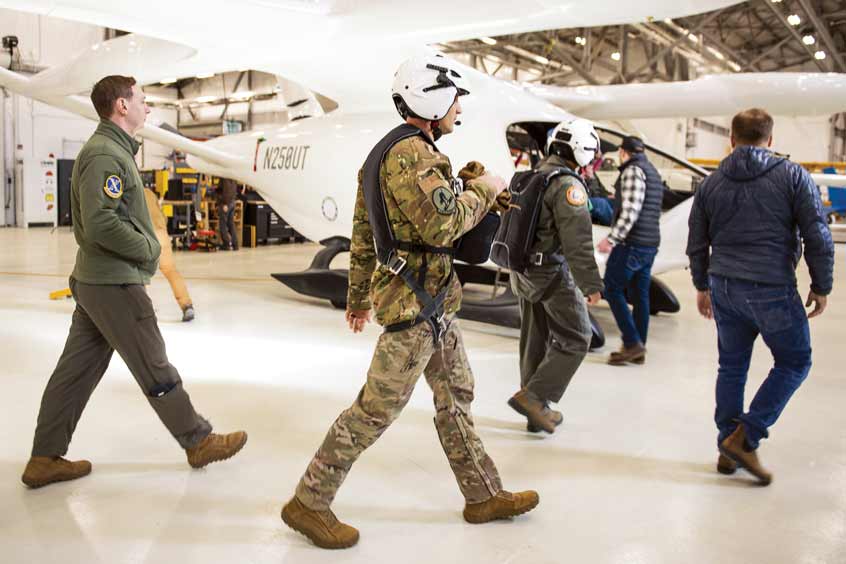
(604, 244, 658, 348)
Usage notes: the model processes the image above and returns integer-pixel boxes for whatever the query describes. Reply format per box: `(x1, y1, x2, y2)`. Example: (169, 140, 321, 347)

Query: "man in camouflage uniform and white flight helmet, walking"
(282, 56, 538, 548)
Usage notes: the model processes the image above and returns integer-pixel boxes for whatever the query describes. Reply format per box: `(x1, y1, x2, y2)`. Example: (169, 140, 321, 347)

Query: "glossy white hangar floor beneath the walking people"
(0, 229, 846, 564)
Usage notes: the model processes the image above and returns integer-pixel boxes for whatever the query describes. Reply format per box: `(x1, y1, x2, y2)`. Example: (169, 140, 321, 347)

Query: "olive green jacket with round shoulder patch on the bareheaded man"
(71, 120, 161, 284)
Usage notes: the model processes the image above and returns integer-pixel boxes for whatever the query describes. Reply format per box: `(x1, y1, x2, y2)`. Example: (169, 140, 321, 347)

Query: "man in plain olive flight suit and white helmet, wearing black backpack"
(508, 119, 603, 433)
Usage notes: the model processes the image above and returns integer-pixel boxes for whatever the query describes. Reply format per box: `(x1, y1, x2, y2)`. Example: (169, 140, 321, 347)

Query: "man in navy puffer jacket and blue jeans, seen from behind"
(687, 109, 834, 485)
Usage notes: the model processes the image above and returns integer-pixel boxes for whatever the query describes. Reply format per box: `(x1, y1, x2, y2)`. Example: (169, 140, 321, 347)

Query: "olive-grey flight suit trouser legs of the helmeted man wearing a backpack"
(520, 283, 591, 402)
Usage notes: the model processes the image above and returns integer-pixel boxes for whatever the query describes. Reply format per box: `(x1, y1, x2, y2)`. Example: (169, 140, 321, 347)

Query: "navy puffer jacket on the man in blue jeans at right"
(687, 146, 834, 296)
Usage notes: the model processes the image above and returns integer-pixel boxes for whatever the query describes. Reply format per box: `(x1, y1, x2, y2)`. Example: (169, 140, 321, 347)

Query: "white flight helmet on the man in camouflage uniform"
(391, 54, 470, 121)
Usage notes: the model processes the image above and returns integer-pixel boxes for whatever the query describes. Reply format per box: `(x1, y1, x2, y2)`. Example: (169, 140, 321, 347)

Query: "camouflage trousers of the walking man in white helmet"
(296, 319, 502, 510)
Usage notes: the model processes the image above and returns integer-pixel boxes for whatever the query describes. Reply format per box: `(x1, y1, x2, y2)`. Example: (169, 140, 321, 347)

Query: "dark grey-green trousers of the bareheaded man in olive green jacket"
(32, 278, 212, 456)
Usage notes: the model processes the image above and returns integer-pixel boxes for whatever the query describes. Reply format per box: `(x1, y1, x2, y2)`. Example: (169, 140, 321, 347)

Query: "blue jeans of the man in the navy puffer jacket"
(710, 275, 811, 449)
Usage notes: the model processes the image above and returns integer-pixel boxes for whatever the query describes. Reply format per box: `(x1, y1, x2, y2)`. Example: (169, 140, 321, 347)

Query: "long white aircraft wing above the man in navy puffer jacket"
(527, 73, 846, 120)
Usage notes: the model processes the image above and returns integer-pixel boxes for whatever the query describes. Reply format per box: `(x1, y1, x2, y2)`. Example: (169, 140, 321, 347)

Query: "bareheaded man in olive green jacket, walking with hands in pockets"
(22, 76, 247, 488)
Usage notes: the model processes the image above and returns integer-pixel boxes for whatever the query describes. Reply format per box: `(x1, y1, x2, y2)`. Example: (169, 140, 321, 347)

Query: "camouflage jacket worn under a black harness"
(347, 136, 497, 326)
